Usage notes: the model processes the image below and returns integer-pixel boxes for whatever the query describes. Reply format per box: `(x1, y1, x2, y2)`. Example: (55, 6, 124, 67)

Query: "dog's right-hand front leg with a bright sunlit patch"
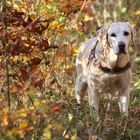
(119, 87, 130, 116)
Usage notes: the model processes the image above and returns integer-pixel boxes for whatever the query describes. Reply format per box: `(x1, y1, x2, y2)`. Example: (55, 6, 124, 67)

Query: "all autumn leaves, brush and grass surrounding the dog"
(0, 0, 140, 140)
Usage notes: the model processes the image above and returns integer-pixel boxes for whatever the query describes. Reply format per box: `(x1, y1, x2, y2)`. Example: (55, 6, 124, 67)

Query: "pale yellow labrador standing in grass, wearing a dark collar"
(75, 22, 135, 116)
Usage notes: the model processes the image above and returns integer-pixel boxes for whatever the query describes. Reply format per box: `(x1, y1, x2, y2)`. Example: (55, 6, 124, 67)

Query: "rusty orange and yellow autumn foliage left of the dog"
(0, 0, 94, 139)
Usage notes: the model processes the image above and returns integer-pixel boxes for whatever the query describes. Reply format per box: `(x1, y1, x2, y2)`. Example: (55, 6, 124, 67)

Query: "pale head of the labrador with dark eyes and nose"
(97, 22, 136, 66)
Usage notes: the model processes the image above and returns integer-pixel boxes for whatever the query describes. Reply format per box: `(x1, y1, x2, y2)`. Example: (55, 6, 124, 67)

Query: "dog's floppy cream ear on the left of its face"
(96, 24, 110, 45)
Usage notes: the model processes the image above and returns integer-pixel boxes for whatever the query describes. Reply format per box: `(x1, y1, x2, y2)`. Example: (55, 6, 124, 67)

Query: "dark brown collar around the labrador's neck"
(99, 61, 131, 74)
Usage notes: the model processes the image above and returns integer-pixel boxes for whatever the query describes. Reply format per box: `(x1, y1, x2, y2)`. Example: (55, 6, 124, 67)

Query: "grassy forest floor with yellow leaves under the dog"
(0, 60, 140, 140)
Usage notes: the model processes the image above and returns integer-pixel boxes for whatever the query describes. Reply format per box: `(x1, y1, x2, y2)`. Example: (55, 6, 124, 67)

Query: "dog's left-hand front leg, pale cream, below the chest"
(88, 84, 99, 118)
